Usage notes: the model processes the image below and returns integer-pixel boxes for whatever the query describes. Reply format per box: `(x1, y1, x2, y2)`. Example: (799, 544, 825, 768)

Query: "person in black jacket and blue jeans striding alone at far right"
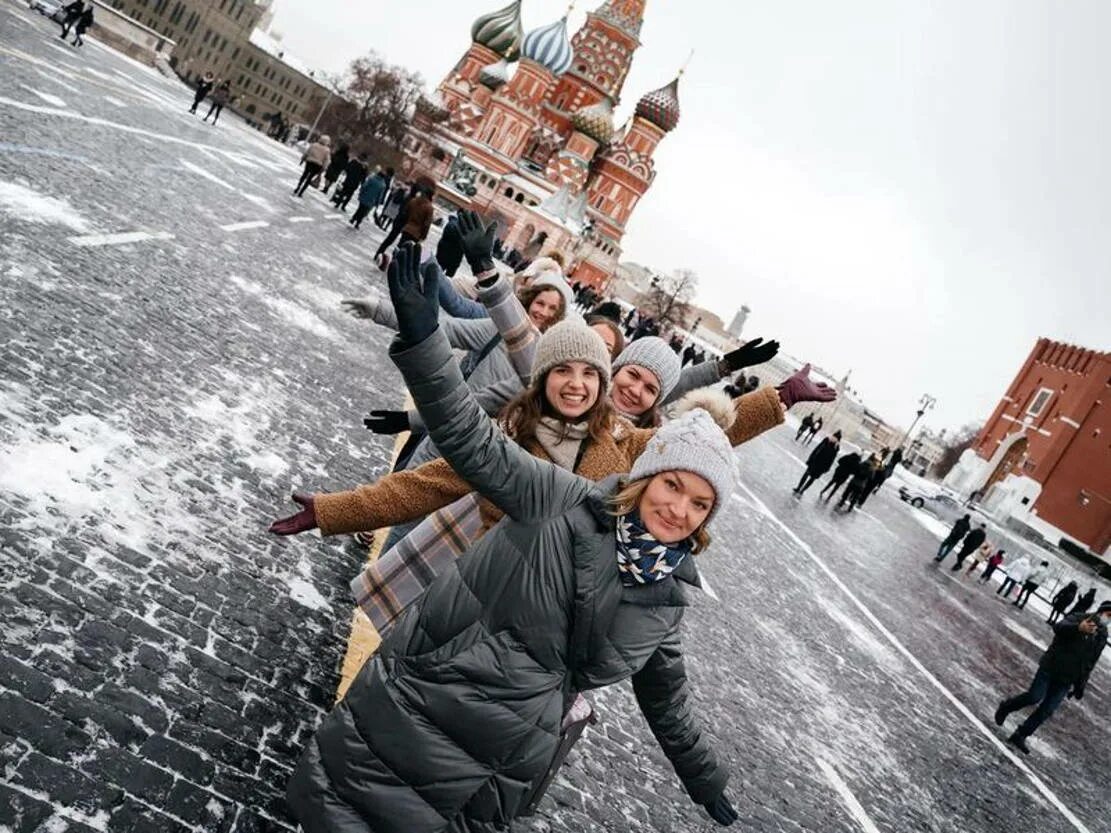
(995, 602, 1111, 755)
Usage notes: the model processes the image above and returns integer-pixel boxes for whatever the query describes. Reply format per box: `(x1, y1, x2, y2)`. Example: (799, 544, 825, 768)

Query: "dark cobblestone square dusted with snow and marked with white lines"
(0, 0, 1111, 833)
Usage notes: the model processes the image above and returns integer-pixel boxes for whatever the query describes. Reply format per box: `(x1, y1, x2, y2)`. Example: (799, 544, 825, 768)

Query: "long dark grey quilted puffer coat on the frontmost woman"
(288, 330, 728, 833)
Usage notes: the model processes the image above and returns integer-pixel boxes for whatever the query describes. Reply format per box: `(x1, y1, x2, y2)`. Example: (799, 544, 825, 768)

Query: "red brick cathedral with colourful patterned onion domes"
(403, 0, 679, 288)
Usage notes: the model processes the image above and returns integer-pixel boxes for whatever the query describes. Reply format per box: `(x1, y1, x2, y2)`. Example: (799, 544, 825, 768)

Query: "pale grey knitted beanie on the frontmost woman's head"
(629, 408, 735, 522)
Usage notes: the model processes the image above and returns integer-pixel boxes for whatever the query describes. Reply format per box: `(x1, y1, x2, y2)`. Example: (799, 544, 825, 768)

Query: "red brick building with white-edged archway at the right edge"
(945, 339, 1111, 555)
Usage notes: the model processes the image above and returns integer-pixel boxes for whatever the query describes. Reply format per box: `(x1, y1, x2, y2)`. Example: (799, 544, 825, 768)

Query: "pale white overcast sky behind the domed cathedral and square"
(273, 0, 1111, 428)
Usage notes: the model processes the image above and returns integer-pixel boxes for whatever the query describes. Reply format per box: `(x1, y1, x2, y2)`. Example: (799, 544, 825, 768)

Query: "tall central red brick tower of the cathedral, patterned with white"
(543, 0, 645, 136)
